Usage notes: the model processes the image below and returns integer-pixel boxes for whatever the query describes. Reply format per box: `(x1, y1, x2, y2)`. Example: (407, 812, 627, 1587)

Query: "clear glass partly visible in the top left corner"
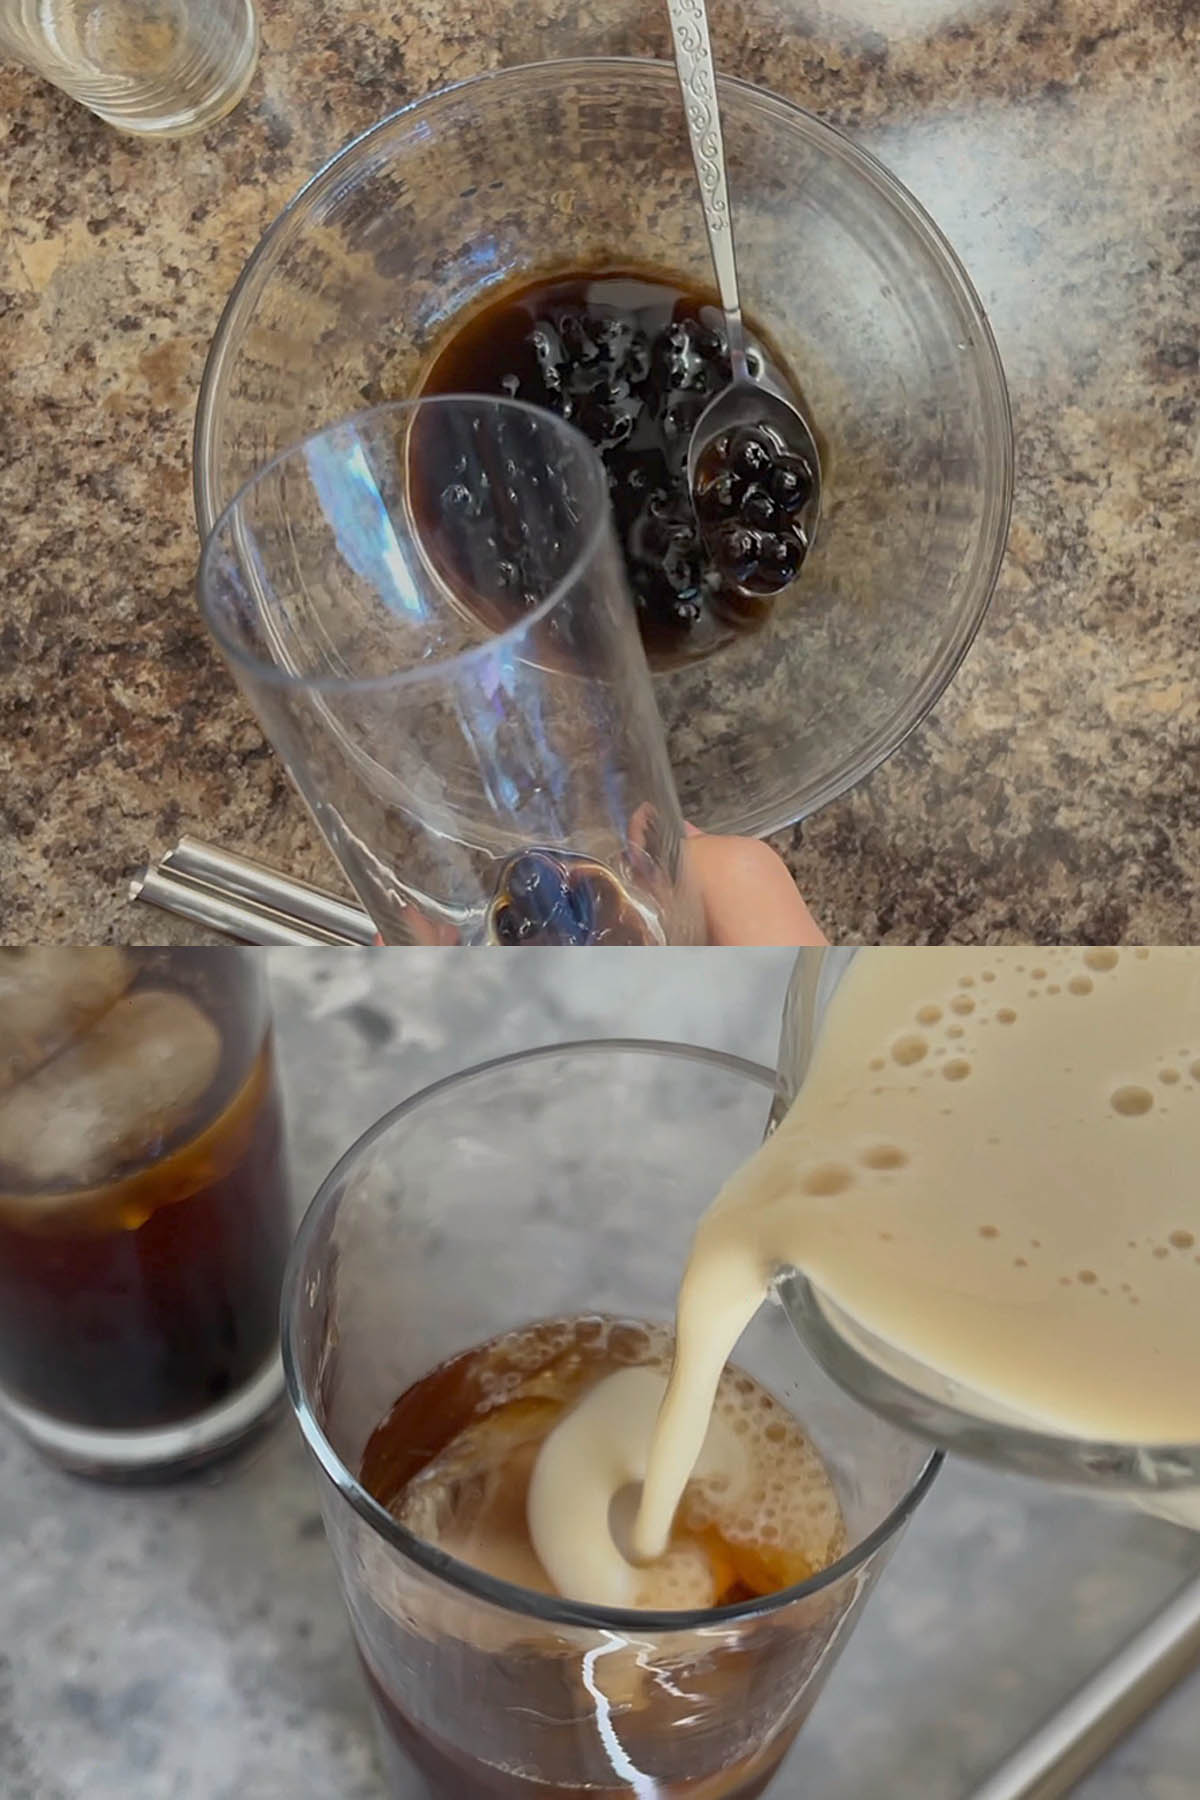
(0, 0, 259, 137)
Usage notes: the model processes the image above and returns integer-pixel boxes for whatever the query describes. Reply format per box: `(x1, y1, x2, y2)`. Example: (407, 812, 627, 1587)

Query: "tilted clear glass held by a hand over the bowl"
(200, 398, 703, 945)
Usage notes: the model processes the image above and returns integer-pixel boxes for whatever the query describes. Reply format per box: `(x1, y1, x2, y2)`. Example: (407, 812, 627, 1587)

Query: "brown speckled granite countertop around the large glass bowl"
(0, 0, 1200, 941)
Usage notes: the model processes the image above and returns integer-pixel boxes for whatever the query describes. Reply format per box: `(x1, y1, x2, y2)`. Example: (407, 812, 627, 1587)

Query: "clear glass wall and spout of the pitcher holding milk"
(774, 949, 1200, 1528)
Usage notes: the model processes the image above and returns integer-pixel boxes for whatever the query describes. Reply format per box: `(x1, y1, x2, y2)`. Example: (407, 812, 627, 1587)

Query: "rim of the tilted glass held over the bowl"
(196, 392, 615, 695)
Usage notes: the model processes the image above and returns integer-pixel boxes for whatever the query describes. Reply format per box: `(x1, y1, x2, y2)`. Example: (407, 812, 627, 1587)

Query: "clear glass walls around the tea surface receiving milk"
(282, 1042, 939, 1800)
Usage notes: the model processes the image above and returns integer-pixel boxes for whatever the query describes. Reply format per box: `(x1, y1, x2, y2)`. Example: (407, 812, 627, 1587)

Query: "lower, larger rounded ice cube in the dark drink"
(0, 988, 221, 1210)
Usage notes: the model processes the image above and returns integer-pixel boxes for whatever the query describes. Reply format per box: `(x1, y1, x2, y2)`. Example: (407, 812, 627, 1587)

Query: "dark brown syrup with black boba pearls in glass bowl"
(421, 270, 813, 666)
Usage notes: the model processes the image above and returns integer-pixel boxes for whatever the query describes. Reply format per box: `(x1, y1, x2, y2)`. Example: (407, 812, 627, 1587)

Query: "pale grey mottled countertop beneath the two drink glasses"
(0, 950, 1200, 1800)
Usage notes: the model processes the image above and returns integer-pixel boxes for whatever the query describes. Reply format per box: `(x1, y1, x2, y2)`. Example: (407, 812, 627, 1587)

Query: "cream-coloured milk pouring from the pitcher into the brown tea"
(529, 947, 1200, 1604)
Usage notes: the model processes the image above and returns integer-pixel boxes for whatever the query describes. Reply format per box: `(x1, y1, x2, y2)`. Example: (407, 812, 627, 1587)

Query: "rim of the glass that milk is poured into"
(281, 1037, 945, 1634)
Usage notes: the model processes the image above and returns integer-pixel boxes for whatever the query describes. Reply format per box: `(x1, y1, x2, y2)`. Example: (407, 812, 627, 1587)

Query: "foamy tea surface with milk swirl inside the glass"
(362, 1318, 844, 1611)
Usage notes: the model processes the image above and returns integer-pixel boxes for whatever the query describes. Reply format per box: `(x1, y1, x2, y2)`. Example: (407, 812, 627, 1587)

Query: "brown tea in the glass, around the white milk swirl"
(360, 1316, 846, 1800)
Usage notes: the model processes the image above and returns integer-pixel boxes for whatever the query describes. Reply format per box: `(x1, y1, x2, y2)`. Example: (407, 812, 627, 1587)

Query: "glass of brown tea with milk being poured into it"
(282, 1042, 937, 1800)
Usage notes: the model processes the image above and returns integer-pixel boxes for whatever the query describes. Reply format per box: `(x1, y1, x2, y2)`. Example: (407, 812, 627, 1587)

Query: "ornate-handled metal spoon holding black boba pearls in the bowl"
(667, 0, 820, 596)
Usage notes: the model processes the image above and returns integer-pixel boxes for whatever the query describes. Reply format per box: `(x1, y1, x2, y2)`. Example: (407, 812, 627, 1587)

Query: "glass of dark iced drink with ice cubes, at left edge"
(0, 949, 290, 1478)
